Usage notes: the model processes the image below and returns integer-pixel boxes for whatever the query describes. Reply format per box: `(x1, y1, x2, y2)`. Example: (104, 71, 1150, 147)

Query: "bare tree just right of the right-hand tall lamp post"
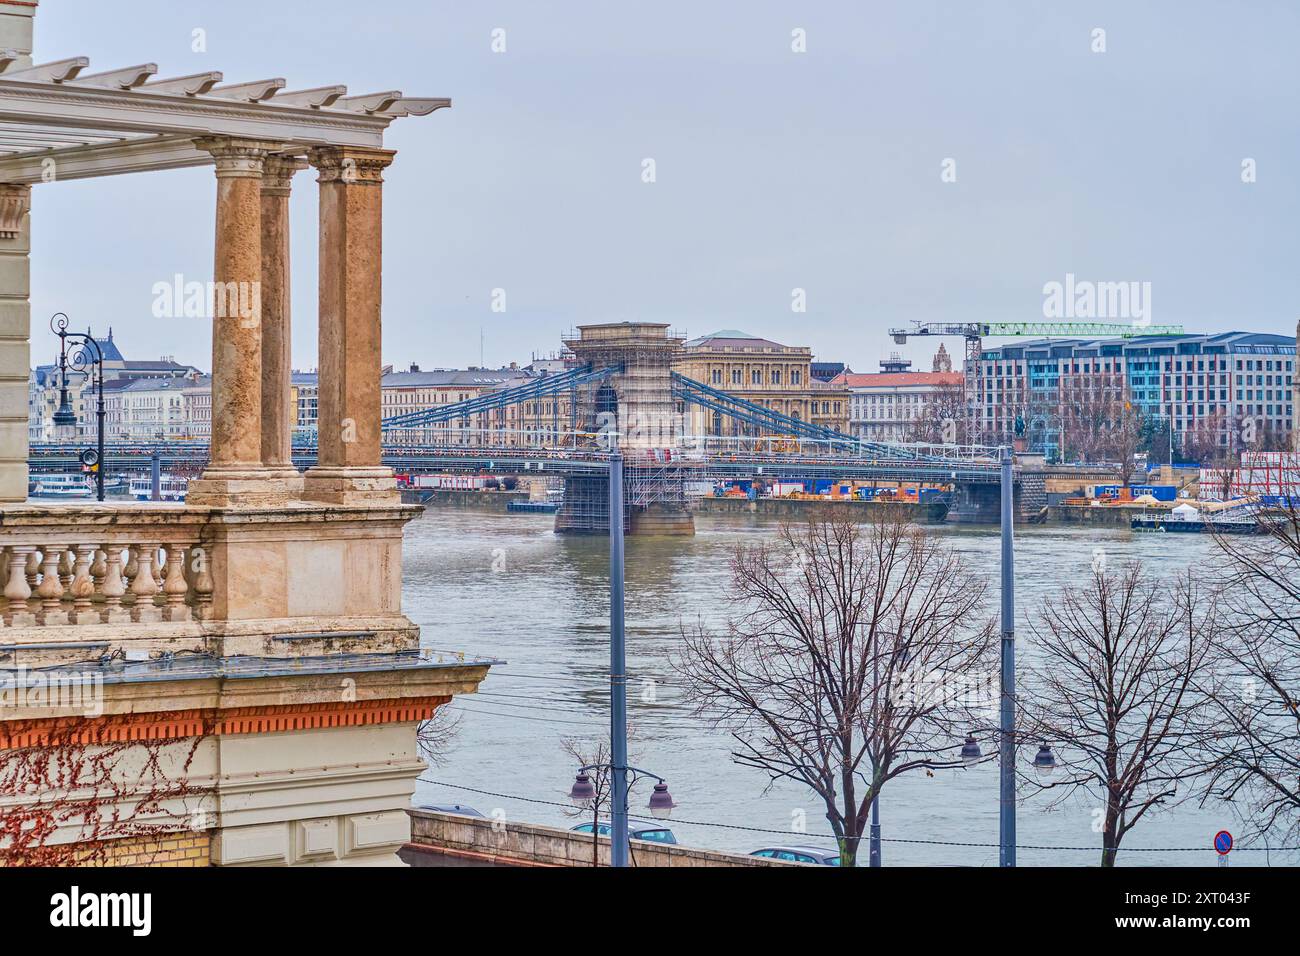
(1022, 562, 1216, 866)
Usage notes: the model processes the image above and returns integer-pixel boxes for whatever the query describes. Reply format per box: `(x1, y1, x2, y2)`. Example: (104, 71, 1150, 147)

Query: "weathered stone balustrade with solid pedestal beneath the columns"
(0, 502, 419, 667)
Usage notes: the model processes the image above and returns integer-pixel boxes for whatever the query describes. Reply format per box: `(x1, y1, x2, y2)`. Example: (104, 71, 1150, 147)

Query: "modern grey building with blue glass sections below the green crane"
(974, 332, 1296, 455)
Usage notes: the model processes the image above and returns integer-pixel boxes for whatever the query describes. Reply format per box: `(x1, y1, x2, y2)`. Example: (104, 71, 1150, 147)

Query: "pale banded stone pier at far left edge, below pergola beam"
(0, 183, 31, 502)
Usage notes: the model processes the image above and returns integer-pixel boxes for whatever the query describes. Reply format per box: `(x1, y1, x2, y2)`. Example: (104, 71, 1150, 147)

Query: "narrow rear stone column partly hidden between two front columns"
(261, 156, 307, 493)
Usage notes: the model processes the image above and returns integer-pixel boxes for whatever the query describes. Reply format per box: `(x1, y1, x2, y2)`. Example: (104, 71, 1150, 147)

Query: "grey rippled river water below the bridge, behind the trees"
(403, 507, 1296, 866)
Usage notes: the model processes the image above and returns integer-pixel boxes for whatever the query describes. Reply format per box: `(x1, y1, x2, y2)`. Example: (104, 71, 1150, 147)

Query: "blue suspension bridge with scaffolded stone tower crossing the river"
(30, 323, 1041, 533)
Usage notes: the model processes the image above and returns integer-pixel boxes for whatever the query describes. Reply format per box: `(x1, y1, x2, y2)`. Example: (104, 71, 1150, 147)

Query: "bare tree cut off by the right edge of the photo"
(1206, 499, 1300, 836)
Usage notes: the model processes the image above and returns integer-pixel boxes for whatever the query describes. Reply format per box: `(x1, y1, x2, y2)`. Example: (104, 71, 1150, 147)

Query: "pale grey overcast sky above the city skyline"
(33, 0, 1300, 372)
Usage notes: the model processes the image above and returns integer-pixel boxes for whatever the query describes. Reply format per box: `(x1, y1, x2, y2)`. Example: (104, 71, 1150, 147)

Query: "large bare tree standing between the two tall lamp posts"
(677, 511, 995, 866)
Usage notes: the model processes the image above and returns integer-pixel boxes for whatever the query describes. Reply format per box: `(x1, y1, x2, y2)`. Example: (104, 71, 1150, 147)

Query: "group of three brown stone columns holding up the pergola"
(187, 137, 397, 507)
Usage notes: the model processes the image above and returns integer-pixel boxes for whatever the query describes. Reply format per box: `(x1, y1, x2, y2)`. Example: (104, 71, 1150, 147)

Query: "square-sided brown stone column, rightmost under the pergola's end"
(303, 147, 399, 505)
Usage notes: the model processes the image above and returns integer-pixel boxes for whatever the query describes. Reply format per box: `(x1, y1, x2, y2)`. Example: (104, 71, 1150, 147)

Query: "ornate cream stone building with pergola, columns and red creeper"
(0, 0, 491, 866)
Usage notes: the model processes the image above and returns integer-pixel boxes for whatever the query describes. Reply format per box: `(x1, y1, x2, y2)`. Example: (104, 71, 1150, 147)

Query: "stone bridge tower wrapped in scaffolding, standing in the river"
(555, 323, 696, 535)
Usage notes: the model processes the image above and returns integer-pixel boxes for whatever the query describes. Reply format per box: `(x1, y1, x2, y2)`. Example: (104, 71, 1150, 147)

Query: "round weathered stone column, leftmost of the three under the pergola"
(186, 137, 287, 507)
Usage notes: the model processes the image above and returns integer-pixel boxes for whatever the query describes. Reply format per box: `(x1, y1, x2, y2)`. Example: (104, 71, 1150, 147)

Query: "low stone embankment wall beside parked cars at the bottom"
(403, 809, 795, 866)
